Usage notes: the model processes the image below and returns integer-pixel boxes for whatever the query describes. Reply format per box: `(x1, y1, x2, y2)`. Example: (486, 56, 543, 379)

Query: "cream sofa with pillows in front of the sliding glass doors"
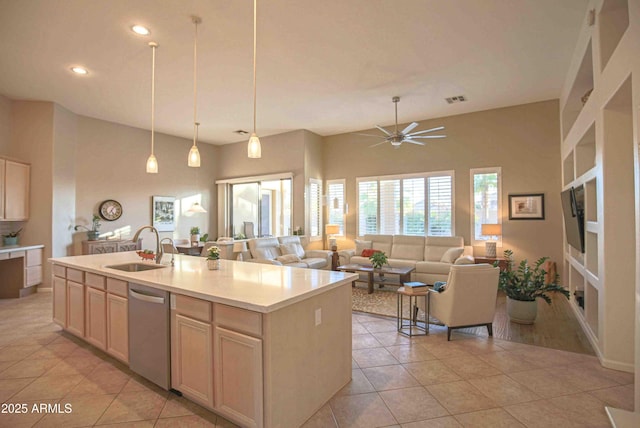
(247, 236, 331, 269)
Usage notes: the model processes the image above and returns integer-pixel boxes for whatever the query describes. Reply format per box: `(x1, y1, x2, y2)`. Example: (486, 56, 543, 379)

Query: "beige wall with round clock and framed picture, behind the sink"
(72, 116, 219, 251)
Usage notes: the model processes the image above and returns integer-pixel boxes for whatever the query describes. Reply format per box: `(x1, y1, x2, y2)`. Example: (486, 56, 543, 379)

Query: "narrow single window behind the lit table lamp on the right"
(470, 167, 502, 246)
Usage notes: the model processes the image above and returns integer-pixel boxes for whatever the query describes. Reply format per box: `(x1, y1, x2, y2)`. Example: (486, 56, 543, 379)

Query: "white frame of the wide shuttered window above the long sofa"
(356, 170, 456, 238)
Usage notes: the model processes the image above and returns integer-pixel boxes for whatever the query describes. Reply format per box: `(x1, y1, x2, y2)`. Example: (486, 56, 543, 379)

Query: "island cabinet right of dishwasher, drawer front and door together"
(171, 295, 214, 408)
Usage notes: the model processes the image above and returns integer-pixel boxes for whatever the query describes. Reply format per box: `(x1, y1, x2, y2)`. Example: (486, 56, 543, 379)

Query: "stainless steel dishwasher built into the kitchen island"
(129, 283, 171, 390)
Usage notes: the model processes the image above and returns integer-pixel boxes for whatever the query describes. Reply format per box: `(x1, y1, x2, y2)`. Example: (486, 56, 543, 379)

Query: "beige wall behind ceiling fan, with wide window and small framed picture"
(323, 100, 562, 267)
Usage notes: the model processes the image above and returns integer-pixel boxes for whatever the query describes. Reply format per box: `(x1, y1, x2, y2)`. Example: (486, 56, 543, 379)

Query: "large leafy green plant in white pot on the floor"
(494, 250, 569, 324)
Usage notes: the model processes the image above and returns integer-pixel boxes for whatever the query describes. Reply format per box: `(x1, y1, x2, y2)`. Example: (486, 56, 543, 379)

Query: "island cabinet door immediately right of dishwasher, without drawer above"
(171, 314, 213, 408)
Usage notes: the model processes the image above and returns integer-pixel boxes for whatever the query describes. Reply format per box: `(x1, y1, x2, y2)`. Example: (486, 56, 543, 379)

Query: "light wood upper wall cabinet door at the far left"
(4, 160, 31, 221)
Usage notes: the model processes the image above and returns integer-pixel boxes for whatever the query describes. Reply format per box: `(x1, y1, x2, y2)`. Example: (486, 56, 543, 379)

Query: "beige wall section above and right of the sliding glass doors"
(218, 130, 308, 234)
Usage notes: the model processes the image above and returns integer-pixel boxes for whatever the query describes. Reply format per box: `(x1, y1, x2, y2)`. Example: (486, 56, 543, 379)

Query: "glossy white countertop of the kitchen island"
(49, 251, 357, 313)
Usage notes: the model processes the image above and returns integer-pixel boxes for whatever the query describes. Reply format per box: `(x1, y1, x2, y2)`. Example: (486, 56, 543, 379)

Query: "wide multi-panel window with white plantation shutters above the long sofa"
(357, 171, 454, 236)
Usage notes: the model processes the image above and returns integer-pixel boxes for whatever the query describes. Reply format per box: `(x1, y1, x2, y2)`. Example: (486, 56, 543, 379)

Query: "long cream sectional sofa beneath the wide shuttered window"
(339, 235, 475, 285)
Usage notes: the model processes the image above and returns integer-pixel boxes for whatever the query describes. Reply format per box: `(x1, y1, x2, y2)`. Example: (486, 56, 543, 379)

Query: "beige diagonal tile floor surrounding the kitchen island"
(0, 293, 633, 428)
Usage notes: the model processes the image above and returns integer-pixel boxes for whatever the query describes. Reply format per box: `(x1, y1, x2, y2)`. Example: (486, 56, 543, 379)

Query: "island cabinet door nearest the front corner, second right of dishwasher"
(214, 326, 263, 427)
